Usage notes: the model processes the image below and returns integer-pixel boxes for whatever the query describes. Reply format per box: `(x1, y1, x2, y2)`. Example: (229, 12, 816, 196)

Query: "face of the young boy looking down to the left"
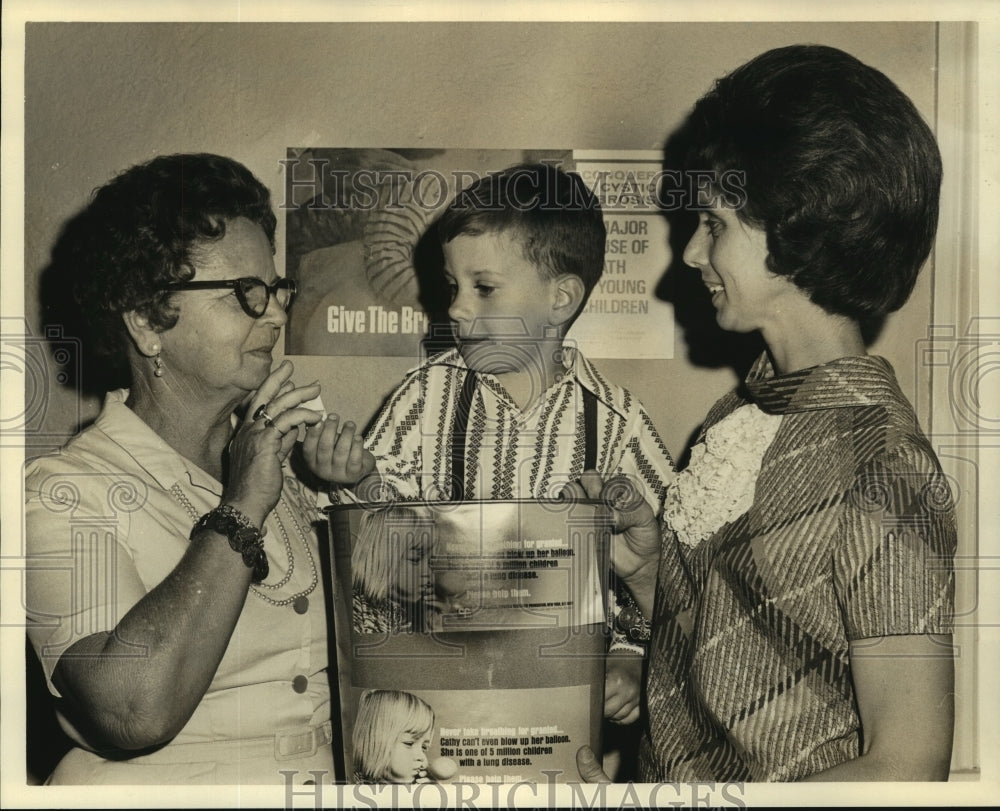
(444, 233, 557, 374)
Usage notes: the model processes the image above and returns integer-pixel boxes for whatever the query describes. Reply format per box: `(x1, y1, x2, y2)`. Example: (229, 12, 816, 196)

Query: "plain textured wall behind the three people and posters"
(24, 22, 948, 464)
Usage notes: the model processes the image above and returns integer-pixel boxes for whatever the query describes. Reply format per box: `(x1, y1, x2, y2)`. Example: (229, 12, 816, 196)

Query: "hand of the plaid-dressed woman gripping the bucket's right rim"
(564, 470, 661, 617)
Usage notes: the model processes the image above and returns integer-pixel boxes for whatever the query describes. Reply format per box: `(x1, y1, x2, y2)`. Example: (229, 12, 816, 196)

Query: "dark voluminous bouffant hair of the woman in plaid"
(685, 45, 941, 322)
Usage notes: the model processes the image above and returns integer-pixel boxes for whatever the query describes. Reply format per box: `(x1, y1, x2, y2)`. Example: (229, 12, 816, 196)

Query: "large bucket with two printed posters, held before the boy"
(330, 501, 610, 783)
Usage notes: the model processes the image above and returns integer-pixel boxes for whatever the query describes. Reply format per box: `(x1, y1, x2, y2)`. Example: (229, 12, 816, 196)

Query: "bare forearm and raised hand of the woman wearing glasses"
(42, 361, 320, 750)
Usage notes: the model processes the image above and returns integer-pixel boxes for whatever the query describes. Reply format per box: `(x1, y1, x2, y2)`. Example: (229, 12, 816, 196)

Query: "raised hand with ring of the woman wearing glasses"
(222, 360, 322, 524)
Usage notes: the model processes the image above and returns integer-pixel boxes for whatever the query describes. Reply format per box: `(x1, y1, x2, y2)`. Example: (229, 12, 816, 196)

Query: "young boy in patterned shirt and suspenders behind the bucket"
(306, 164, 673, 772)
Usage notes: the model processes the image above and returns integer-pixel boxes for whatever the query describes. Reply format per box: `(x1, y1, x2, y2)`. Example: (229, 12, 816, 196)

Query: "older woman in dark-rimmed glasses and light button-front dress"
(25, 155, 370, 784)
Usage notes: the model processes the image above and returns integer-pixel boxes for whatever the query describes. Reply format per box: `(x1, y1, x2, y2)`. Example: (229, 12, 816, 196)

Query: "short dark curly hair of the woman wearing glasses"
(66, 154, 277, 363)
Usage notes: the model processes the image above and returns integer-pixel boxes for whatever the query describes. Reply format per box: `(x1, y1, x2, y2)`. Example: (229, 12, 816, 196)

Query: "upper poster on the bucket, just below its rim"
(350, 501, 607, 634)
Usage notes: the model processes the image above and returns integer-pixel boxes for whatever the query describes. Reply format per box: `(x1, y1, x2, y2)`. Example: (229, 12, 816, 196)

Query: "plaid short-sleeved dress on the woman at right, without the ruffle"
(640, 357, 956, 781)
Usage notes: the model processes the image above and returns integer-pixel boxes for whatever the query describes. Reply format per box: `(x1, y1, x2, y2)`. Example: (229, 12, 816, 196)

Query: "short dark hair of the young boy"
(437, 163, 607, 313)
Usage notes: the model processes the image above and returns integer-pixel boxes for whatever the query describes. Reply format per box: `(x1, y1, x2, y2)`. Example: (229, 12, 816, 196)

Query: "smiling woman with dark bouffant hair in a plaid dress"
(580, 46, 956, 781)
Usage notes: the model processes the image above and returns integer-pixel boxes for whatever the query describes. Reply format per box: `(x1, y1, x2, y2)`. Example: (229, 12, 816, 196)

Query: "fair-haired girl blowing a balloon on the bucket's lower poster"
(353, 690, 456, 783)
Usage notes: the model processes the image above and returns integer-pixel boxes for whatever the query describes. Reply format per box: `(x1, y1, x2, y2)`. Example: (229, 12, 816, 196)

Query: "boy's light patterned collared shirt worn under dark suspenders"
(366, 347, 673, 514)
